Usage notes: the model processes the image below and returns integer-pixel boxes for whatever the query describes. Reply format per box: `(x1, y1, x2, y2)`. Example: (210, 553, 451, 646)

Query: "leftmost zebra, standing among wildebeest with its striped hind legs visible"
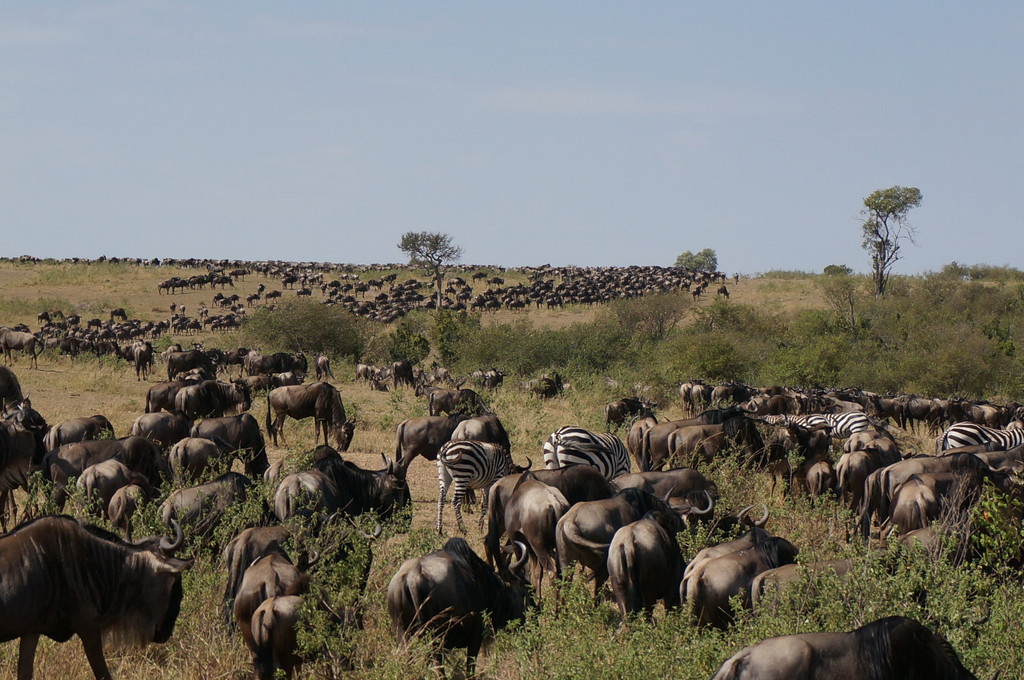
(437, 439, 512, 534)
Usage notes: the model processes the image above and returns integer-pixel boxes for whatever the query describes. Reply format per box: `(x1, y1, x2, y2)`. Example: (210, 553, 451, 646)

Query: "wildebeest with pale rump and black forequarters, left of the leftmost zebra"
(273, 447, 412, 521)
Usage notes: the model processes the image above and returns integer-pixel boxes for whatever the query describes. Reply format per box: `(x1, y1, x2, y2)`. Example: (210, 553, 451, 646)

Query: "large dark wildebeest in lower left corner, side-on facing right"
(0, 515, 191, 680)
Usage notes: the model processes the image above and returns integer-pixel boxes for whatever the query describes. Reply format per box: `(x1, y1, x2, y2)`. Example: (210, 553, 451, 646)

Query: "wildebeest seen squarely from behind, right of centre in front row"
(607, 503, 686, 620)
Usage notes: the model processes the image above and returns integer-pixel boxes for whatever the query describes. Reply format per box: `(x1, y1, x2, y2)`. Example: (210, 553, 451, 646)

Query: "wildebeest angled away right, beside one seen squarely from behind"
(680, 537, 799, 630)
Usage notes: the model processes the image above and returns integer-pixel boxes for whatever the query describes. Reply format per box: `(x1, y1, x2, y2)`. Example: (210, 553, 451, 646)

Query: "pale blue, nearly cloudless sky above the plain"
(0, 0, 1024, 273)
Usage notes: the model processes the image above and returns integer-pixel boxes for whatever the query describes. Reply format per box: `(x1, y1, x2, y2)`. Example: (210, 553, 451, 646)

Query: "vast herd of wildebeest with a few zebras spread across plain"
(0, 262, 1007, 680)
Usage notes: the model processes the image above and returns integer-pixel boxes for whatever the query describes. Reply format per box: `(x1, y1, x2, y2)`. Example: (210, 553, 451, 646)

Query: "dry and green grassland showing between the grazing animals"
(0, 263, 1024, 680)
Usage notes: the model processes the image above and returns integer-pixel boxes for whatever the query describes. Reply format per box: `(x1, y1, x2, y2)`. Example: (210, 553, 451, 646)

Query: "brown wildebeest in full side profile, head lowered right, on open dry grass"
(266, 382, 355, 451)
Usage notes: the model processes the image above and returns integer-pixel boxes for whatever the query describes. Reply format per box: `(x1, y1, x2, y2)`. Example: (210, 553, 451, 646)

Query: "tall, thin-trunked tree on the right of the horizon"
(860, 185, 922, 299)
